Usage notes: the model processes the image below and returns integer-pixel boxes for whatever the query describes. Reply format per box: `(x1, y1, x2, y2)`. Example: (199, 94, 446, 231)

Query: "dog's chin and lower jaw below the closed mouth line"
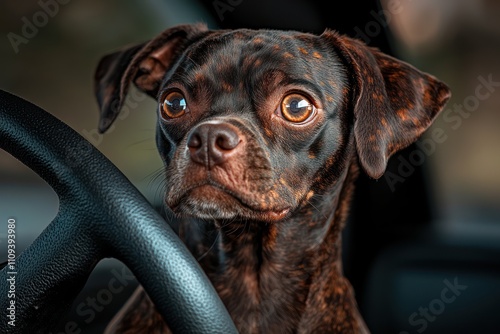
(167, 185, 291, 223)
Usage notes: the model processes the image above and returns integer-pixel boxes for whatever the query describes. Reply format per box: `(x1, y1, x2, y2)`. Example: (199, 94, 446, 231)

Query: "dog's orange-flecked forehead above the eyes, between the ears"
(166, 30, 340, 98)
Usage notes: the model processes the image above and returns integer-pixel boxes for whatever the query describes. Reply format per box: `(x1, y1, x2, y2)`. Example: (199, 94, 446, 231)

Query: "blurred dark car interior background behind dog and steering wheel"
(0, 0, 500, 333)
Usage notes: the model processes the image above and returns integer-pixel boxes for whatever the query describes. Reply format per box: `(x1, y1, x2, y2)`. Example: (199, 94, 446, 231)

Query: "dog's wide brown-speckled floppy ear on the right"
(323, 31, 450, 178)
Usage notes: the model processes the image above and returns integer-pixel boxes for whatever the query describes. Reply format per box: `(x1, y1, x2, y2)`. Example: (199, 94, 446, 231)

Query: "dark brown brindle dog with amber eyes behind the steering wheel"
(95, 24, 450, 333)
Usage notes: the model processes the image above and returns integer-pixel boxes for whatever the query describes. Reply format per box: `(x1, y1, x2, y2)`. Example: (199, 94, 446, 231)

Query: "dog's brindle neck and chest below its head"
(180, 163, 364, 333)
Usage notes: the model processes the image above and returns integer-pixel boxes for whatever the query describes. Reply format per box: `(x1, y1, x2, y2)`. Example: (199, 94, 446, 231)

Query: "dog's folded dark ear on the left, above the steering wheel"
(94, 24, 207, 133)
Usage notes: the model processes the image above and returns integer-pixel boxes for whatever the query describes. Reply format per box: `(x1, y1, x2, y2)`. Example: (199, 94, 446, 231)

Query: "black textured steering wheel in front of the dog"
(0, 90, 237, 333)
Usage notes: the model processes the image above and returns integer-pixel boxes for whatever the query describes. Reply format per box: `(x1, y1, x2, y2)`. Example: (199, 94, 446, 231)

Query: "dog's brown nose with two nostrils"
(187, 123, 242, 169)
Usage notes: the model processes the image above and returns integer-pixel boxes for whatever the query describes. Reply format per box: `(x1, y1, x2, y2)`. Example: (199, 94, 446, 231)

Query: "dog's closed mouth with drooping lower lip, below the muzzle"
(166, 181, 291, 222)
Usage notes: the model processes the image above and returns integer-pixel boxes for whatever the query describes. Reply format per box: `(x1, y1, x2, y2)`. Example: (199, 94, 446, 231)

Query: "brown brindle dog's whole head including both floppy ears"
(96, 25, 449, 222)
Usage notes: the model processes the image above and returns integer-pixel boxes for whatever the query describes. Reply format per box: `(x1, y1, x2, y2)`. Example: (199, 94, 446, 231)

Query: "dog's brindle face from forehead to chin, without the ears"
(157, 31, 350, 221)
